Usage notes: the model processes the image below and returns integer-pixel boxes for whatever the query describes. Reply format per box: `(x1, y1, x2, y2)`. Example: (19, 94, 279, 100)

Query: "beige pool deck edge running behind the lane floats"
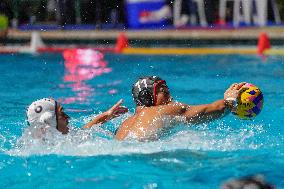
(7, 26, 284, 40)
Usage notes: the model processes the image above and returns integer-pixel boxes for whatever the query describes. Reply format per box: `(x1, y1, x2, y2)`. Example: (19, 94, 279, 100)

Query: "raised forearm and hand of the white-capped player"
(83, 99, 128, 129)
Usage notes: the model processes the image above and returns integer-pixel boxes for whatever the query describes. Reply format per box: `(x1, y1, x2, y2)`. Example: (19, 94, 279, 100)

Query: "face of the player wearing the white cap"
(57, 104, 70, 134)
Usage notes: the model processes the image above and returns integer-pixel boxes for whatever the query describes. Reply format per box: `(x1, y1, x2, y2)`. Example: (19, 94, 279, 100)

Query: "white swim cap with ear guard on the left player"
(27, 98, 57, 128)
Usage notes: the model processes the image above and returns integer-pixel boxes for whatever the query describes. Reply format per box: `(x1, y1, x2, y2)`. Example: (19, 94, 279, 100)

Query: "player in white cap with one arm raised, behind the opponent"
(26, 98, 128, 138)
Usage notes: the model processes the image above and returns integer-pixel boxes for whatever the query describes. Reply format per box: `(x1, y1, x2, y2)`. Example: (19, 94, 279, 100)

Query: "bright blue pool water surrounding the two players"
(0, 54, 284, 189)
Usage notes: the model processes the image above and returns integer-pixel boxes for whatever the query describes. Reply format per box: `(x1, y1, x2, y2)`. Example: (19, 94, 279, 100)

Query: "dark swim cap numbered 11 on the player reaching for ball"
(132, 76, 166, 107)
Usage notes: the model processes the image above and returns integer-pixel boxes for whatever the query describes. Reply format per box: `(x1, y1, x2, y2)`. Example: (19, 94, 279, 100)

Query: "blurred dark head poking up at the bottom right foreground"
(221, 175, 273, 189)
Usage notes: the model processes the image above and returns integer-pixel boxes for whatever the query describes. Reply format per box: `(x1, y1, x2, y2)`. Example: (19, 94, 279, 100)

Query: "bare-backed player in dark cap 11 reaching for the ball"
(115, 76, 244, 141)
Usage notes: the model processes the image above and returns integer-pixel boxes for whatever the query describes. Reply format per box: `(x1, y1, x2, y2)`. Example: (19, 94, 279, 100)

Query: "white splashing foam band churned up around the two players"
(3, 114, 277, 156)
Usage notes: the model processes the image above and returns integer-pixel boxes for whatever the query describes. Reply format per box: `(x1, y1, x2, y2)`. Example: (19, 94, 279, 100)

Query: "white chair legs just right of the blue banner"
(173, 0, 207, 27)
